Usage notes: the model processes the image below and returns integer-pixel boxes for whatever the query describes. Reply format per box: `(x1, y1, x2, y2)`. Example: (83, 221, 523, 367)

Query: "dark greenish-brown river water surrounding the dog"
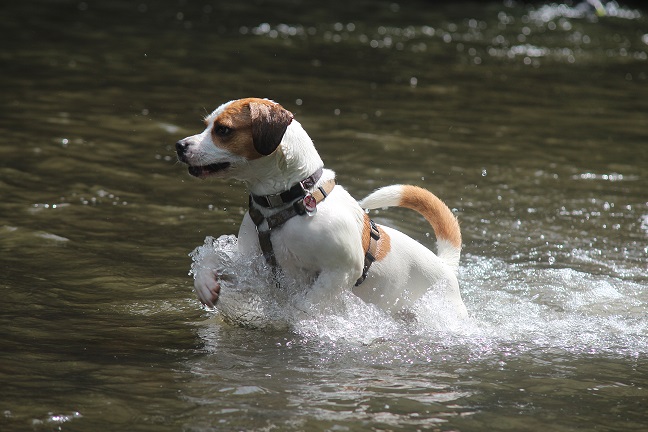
(0, 0, 648, 431)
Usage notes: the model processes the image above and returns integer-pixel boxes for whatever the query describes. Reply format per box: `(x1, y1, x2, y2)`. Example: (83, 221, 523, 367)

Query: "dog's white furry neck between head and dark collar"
(241, 120, 324, 195)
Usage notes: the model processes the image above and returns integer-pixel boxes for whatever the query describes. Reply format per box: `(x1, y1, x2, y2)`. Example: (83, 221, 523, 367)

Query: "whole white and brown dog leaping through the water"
(176, 98, 467, 317)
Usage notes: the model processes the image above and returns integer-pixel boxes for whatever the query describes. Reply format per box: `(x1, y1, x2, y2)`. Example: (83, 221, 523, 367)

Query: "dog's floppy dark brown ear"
(250, 102, 293, 156)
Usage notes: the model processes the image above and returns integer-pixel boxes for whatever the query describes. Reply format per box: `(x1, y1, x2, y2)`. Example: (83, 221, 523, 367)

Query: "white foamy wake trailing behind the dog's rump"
(460, 257, 648, 356)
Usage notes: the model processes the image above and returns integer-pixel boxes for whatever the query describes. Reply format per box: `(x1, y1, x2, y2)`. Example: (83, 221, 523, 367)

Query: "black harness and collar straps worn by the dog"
(248, 168, 380, 286)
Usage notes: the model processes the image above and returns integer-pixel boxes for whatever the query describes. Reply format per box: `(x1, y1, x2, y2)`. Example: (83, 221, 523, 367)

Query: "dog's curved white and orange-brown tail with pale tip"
(359, 185, 461, 269)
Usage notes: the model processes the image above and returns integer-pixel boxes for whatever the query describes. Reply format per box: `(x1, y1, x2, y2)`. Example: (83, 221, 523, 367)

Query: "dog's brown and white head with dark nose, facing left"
(176, 98, 293, 178)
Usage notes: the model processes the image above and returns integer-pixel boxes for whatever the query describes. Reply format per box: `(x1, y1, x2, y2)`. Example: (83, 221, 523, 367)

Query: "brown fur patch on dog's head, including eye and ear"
(211, 98, 293, 160)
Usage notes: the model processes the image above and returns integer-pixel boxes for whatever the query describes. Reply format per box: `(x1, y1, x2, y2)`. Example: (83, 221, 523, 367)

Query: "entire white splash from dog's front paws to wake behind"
(191, 235, 648, 356)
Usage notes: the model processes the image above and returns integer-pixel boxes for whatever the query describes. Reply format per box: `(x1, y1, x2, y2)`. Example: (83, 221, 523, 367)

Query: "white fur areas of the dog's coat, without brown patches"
(178, 102, 467, 317)
